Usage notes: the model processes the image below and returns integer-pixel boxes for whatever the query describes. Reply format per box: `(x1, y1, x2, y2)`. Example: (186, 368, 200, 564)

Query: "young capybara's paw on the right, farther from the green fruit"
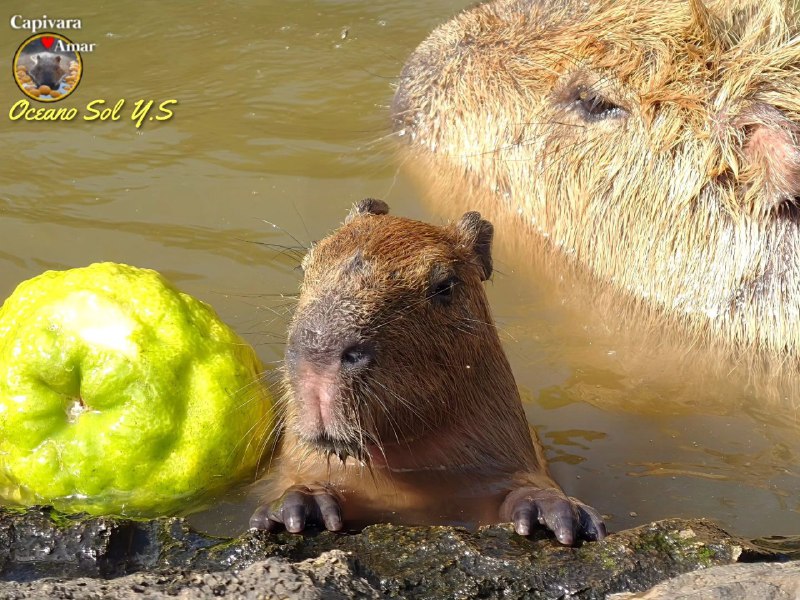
(500, 487, 606, 546)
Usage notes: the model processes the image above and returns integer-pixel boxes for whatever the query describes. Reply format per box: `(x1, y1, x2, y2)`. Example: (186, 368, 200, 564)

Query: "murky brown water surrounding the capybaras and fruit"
(0, 0, 800, 535)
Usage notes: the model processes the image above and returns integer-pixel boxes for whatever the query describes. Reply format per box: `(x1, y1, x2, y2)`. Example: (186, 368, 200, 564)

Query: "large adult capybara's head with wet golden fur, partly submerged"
(393, 0, 800, 356)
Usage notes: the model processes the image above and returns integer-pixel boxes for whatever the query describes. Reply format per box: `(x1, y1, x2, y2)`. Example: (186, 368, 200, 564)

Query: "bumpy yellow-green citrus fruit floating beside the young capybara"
(0, 263, 272, 516)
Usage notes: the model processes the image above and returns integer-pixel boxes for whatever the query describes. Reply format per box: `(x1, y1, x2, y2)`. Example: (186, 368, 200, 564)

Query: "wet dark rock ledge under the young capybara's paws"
(0, 509, 786, 600)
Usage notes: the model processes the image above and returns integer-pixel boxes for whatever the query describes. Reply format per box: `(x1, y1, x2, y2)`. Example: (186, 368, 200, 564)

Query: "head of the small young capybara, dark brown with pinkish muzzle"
(286, 199, 518, 461)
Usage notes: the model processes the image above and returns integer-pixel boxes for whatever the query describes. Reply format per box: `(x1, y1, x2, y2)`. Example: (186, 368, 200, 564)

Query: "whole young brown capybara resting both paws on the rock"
(250, 199, 605, 544)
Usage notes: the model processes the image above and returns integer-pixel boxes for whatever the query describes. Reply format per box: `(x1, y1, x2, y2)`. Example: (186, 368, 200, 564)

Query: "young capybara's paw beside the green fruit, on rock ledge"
(250, 485, 342, 533)
